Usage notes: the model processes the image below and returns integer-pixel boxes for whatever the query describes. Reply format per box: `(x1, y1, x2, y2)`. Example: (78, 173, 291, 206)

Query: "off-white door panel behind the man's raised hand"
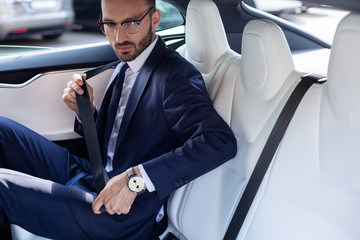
(0, 68, 113, 141)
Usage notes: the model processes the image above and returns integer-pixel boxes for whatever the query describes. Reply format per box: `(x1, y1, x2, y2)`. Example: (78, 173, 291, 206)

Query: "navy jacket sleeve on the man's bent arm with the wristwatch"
(143, 61, 237, 199)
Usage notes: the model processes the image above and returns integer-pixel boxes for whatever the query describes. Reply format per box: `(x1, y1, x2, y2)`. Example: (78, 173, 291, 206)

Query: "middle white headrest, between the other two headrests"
(241, 20, 295, 100)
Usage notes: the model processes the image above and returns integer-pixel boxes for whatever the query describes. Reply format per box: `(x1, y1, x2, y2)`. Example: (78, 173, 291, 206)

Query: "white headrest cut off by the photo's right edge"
(328, 13, 360, 130)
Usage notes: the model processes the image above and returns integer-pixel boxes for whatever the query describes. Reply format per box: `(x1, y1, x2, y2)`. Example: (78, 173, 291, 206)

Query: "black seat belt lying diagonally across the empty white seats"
(224, 74, 326, 240)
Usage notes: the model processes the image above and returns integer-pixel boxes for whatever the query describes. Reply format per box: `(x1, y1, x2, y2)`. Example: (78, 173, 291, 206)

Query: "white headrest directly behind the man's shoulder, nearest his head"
(185, 0, 230, 73)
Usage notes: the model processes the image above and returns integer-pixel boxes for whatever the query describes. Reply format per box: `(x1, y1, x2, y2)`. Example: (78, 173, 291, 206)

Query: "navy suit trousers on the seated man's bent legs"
(0, 117, 156, 240)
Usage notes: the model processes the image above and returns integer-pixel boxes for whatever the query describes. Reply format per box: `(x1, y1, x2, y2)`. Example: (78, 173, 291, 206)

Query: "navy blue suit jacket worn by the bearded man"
(75, 38, 236, 238)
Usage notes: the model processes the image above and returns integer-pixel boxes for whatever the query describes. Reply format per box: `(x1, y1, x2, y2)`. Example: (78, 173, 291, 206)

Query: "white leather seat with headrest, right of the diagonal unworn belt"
(238, 11, 360, 240)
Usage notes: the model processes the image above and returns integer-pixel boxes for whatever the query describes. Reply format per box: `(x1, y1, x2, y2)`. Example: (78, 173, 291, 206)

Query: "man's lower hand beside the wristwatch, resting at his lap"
(92, 172, 136, 215)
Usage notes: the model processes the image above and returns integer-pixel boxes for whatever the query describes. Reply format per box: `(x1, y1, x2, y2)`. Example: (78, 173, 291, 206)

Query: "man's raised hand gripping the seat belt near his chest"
(62, 74, 95, 116)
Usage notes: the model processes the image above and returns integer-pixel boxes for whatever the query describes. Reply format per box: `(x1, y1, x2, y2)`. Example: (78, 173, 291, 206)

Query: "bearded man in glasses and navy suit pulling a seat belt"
(0, 0, 236, 239)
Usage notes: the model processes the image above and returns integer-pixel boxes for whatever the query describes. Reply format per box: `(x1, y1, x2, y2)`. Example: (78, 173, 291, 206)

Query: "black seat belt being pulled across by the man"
(76, 61, 120, 212)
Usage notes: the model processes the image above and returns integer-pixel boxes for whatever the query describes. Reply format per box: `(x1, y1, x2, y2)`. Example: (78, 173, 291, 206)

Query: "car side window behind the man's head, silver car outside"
(0, 0, 185, 53)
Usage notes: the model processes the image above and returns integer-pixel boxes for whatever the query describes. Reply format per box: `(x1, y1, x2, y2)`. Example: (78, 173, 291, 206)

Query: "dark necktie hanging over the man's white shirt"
(103, 63, 129, 155)
